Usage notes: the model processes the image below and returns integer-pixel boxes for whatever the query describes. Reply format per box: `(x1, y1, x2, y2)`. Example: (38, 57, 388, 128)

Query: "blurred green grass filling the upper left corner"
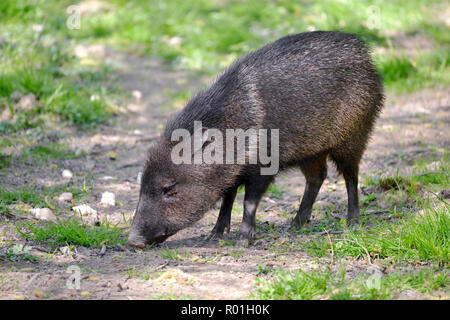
(0, 0, 119, 134)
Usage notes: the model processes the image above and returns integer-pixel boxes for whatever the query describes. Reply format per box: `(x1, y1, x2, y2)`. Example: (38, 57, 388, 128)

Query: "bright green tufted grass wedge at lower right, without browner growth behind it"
(304, 201, 450, 265)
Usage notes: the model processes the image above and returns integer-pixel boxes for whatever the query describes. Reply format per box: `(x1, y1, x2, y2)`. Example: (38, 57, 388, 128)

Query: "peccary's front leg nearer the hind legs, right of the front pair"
(239, 175, 273, 246)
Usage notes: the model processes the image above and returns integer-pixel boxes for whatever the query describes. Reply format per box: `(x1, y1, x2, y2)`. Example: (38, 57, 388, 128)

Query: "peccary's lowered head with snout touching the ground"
(128, 140, 232, 247)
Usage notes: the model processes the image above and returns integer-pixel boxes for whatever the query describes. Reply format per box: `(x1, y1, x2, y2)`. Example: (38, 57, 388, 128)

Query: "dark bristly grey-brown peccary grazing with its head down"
(128, 31, 384, 247)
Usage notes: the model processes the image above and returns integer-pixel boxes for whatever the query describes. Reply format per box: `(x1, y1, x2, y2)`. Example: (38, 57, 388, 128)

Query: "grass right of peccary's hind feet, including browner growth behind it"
(299, 153, 450, 265)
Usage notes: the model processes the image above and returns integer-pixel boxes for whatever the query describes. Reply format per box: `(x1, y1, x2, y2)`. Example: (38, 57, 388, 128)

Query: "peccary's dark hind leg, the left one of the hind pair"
(292, 154, 327, 229)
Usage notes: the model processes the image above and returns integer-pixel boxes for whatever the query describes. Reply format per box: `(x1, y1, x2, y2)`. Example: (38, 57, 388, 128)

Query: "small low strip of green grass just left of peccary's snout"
(16, 217, 126, 247)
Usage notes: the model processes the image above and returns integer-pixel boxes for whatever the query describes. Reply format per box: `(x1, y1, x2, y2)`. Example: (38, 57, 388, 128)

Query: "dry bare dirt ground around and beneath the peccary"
(0, 50, 450, 299)
